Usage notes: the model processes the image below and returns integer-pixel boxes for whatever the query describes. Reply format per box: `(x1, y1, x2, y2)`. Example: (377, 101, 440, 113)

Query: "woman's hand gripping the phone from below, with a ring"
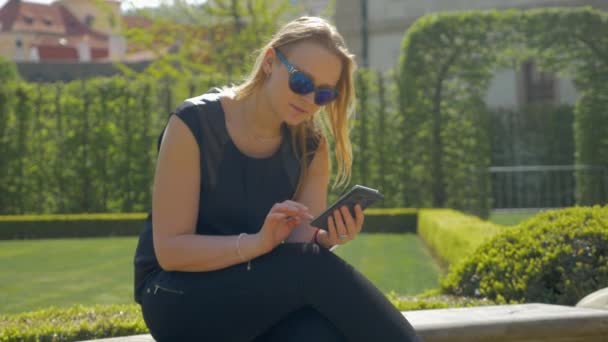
(317, 204, 364, 248)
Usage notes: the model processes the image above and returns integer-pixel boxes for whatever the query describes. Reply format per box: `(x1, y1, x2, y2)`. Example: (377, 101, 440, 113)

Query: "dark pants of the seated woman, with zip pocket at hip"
(142, 243, 421, 342)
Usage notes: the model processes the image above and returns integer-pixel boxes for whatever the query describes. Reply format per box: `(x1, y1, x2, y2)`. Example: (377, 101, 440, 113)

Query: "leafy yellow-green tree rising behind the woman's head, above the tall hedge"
(120, 0, 303, 80)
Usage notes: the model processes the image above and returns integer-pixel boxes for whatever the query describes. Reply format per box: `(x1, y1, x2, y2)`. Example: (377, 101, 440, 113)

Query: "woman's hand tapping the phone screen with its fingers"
(258, 200, 313, 251)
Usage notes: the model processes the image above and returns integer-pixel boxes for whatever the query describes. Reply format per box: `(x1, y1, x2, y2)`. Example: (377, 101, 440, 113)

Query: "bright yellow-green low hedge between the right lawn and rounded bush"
(418, 209, 505, 265)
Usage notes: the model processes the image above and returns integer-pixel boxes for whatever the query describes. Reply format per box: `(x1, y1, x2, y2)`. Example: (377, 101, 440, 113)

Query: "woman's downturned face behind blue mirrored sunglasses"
(264, 42, 342, 126)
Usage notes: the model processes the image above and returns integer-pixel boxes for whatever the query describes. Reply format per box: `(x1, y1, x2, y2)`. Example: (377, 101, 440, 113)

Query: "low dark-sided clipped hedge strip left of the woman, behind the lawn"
(0, 213, 146, 240)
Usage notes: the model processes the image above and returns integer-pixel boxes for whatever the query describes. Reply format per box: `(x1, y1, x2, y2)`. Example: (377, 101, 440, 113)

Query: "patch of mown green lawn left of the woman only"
(0, 237, 137, 313)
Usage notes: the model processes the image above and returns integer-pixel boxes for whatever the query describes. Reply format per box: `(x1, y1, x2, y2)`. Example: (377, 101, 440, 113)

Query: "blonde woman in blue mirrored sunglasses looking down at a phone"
(135, 17, 418, 342)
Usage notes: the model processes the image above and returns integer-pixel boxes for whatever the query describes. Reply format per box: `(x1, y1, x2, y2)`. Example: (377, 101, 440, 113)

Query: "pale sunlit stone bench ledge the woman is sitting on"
(81, 303, 608, 342)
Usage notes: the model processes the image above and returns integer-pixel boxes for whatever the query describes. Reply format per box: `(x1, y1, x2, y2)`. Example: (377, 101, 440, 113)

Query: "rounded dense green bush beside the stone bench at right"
(442, 206, 608, 305)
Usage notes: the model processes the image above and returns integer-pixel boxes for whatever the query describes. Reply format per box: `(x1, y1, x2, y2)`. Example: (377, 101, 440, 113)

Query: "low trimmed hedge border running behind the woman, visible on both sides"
(0, 208, 417, 240)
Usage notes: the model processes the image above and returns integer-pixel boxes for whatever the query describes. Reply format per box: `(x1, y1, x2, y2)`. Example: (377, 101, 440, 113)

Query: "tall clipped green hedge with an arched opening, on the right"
(396, 7, 608, 217)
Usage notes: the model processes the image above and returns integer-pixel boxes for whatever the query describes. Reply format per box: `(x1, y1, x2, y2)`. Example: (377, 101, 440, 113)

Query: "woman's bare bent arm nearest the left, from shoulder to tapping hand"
(152, 115, 302, 271)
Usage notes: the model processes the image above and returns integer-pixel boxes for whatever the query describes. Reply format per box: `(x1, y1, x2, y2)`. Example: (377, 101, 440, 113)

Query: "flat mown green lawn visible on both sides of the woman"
(0, 234, 439, 313)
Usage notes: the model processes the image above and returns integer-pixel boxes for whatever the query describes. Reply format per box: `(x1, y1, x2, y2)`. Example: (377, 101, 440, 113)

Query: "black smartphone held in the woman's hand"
(310, 185, 384, 230)
